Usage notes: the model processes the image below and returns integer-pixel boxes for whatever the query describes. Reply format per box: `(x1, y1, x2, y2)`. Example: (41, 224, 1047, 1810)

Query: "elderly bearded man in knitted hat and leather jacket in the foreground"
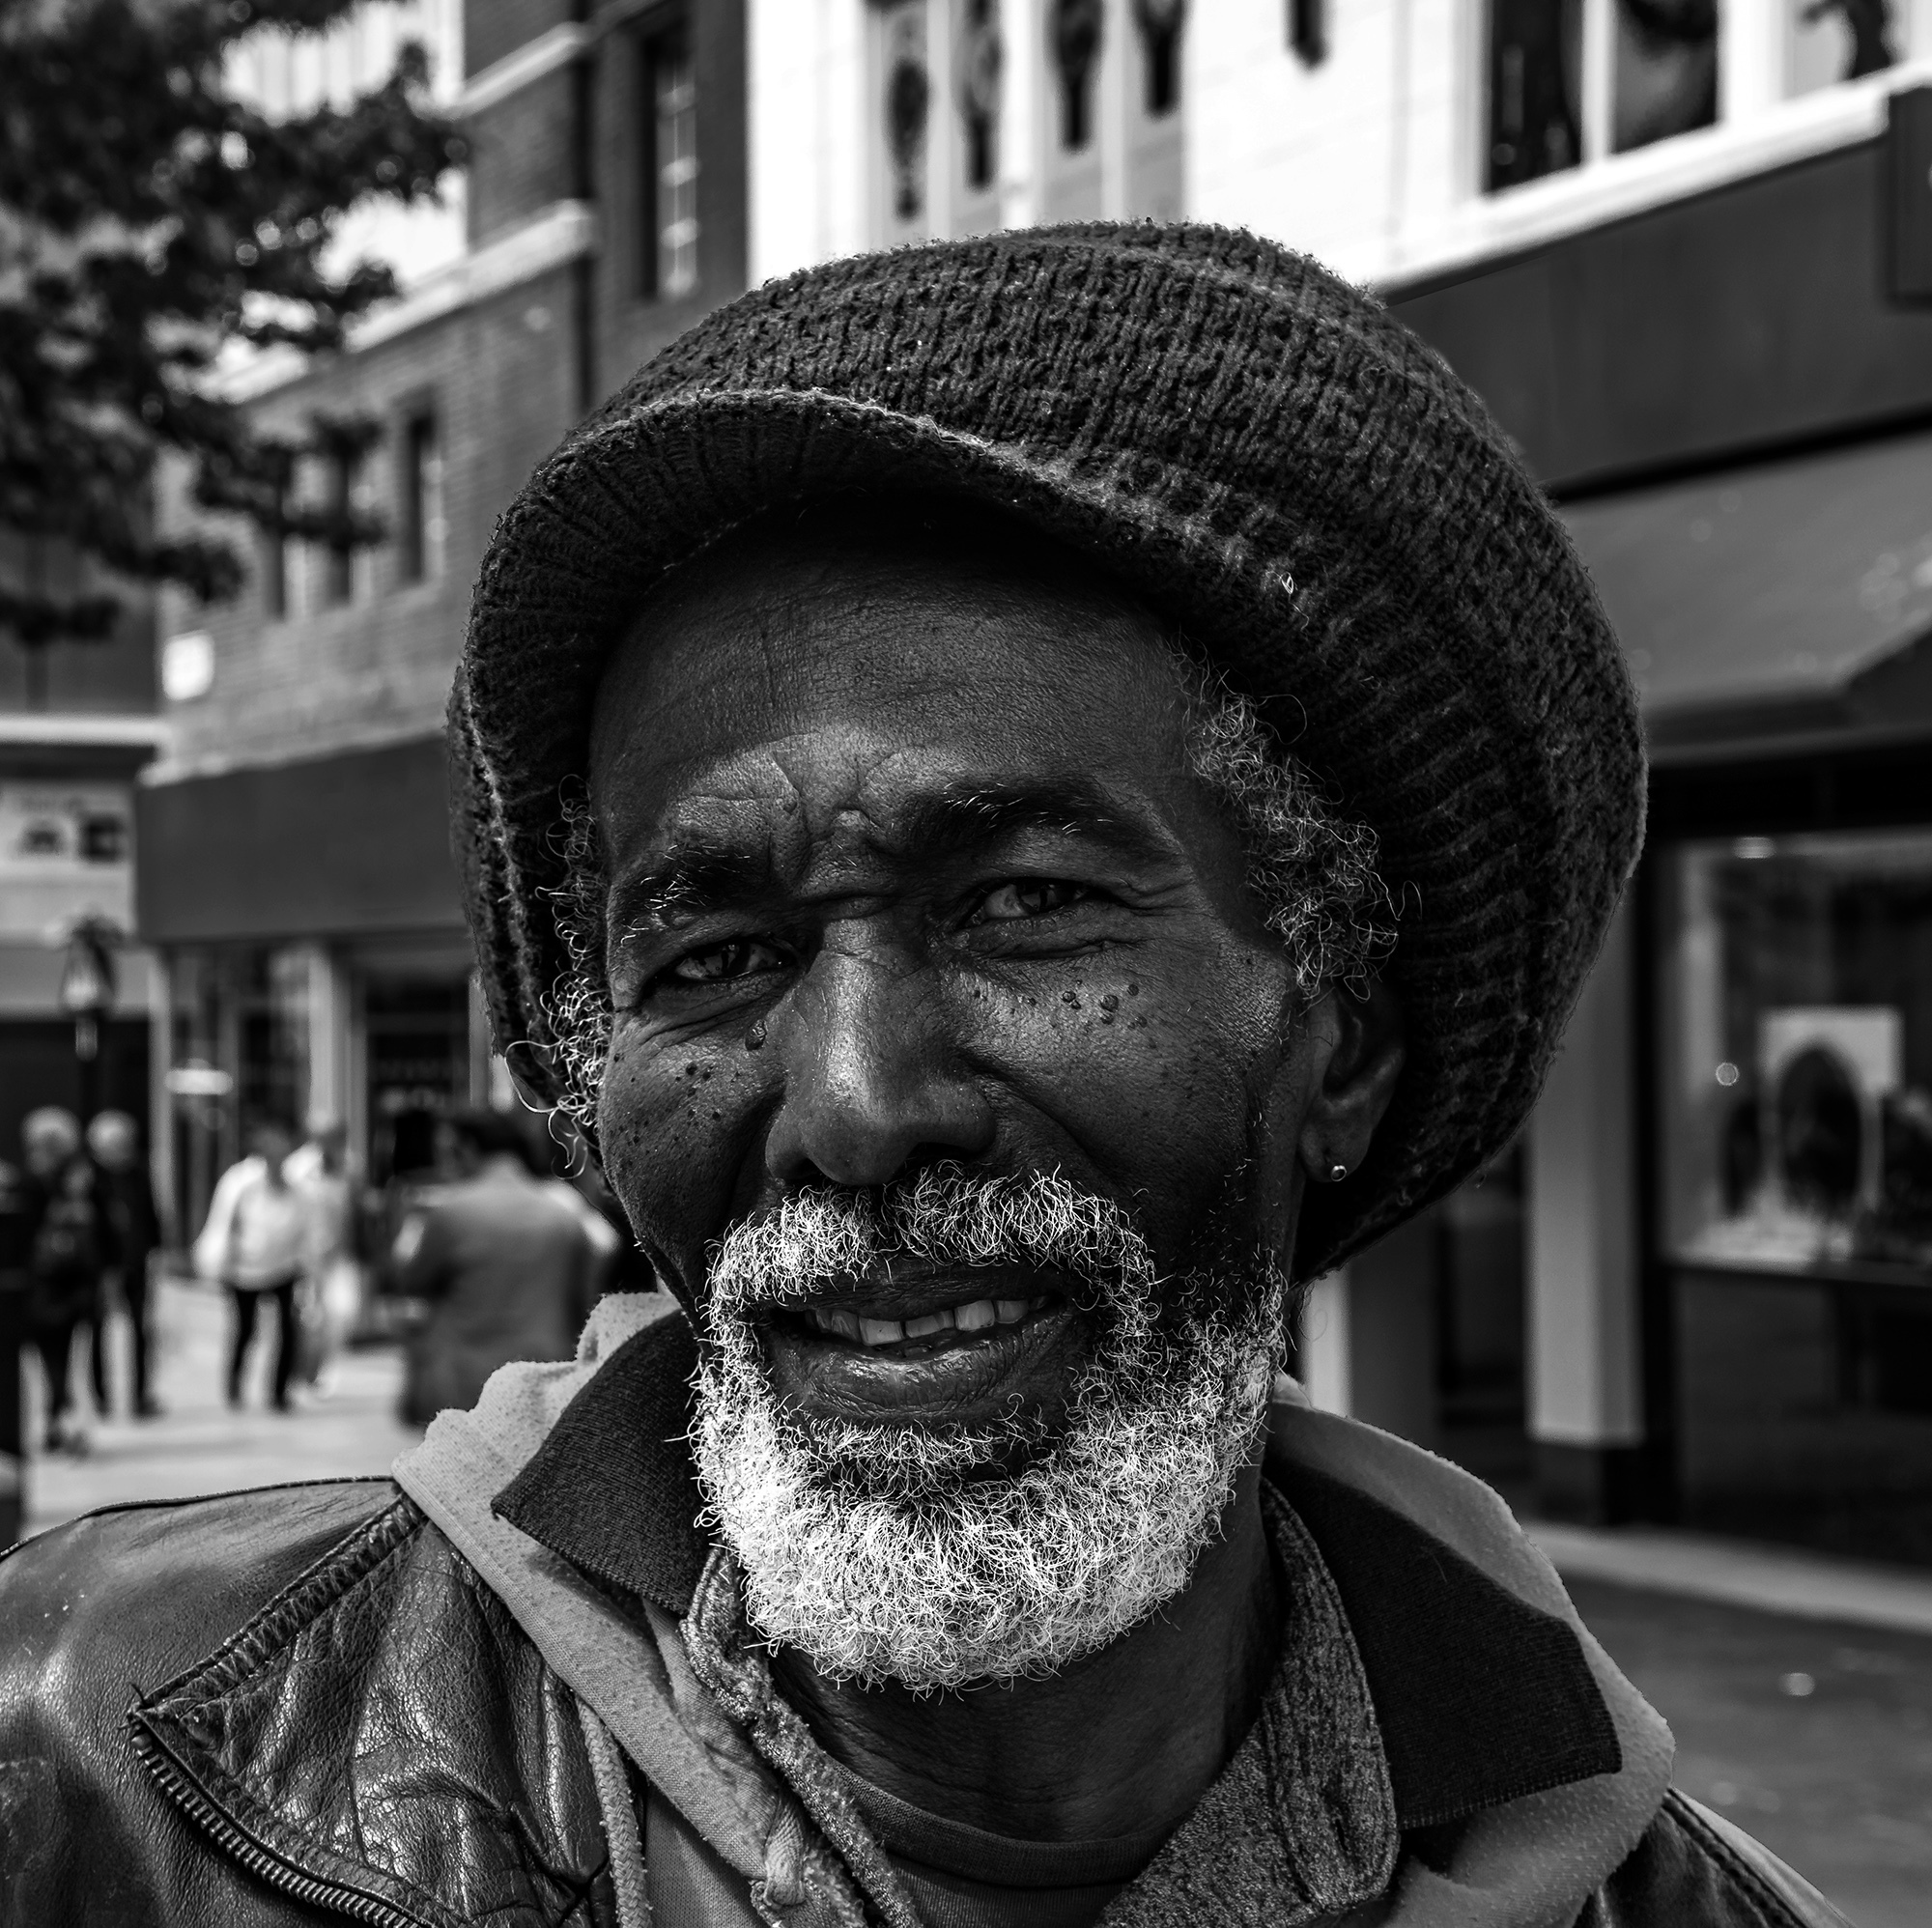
(0, 226, 1835, 1928)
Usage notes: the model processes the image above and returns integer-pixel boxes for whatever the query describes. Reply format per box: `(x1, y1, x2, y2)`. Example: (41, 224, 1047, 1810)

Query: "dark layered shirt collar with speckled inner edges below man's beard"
(460, 1308, 1662, 1924)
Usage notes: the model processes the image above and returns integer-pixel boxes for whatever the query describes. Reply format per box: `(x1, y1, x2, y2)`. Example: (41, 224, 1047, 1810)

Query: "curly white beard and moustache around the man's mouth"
(692, 1169, 1285, 1690)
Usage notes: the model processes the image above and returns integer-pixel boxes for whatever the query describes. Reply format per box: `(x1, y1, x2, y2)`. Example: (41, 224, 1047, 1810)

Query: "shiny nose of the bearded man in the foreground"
(765, 949, 995, 1190)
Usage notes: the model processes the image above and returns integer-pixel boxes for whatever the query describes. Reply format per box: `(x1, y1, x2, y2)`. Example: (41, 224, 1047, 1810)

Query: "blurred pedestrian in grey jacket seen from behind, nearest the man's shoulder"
(396, 1109, 597, 1426)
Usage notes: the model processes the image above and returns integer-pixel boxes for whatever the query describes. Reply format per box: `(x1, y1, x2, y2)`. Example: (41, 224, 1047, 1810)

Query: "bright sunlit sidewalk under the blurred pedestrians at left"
(27, 1279, 419, 1534)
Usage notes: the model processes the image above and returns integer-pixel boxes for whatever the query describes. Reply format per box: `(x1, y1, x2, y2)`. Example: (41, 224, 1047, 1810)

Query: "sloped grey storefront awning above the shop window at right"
(1563, 435, 1932, 750)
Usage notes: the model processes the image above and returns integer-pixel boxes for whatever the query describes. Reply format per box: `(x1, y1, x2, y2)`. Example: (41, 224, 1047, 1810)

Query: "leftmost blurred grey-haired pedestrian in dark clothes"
(19, 1105, 118, 1453)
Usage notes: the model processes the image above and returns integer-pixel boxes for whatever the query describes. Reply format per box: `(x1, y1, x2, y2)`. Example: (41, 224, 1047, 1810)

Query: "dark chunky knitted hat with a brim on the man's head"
(450, 224, 1644, 1277)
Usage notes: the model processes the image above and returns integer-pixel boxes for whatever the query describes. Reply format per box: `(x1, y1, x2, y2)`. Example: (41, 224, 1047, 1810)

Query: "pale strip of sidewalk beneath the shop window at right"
(1522, 1520, 1932, 1634)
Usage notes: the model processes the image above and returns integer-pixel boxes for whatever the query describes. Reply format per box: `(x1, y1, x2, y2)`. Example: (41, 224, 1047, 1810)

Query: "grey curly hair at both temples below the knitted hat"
(547, 643, 1395, 1126)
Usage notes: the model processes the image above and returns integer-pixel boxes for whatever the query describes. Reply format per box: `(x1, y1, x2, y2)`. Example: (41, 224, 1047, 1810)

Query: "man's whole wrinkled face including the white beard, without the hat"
(576, 522, 1393, 1688)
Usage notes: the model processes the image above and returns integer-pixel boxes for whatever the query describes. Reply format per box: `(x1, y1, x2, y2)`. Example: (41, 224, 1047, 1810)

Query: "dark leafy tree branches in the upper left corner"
(0, 0, 464, 649)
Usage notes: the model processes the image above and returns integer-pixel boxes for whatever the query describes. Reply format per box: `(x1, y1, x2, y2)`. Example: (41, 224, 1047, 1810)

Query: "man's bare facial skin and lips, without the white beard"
(591, 529, 1306, 1453)
